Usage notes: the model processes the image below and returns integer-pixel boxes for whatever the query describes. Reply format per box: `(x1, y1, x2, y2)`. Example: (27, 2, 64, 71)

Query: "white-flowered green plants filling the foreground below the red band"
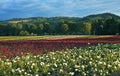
(0, 44, 120, 76)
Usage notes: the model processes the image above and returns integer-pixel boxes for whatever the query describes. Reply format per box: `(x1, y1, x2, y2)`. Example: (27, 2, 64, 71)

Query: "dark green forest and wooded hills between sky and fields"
(0, 13, 120, 36)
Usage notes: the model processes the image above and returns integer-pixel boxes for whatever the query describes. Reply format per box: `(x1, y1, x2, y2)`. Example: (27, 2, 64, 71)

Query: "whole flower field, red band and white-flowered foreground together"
(0, 36, 120, 76)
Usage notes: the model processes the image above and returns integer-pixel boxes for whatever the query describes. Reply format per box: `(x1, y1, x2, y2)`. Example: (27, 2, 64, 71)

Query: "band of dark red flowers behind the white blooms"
(0, 36, 120, 57)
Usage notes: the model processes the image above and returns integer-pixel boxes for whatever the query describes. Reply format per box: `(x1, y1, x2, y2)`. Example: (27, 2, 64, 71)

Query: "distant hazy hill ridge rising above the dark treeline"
(0, 13, 120, 23)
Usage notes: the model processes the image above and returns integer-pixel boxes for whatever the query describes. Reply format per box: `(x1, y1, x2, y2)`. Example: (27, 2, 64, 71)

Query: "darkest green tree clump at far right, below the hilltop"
(92, 18, 120, 35)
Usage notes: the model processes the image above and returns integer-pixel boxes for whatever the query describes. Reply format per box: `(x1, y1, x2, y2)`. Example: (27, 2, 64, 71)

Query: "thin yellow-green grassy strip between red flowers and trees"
(0, 35, 110, 41)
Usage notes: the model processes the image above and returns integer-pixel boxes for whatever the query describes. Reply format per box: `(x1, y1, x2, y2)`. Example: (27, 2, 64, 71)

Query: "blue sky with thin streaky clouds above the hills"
(0, 0, 120, 20)
